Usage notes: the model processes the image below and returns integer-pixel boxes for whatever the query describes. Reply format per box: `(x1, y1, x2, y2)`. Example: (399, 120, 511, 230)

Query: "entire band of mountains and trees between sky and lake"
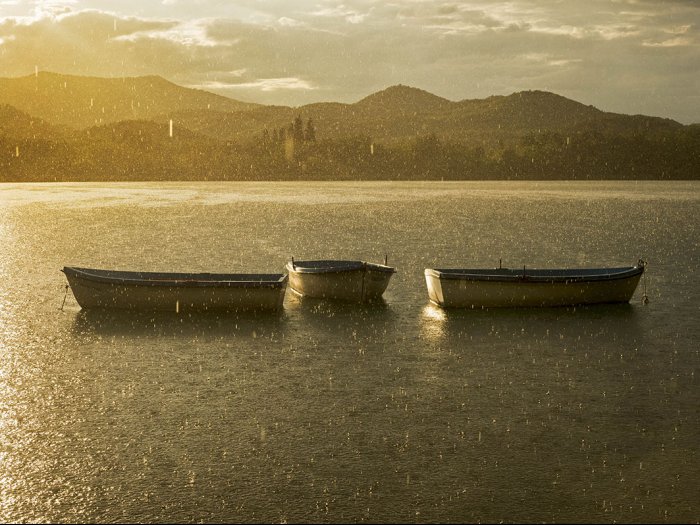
(0, 72, 700, 182)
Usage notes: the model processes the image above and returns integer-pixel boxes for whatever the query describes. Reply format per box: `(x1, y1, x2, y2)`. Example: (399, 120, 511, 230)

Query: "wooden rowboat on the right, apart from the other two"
(425, 260, 645, 308)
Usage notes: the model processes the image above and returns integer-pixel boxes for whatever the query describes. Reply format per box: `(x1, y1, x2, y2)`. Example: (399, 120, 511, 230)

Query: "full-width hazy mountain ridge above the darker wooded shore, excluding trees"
(0, 72, 682, 140)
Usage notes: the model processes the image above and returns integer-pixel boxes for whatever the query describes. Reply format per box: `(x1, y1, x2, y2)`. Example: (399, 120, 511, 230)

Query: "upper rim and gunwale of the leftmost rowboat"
(61, 266, 289, 288)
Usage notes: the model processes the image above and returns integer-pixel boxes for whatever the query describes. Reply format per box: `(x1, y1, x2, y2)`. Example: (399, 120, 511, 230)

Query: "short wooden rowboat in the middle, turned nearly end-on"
(286, 259, 396, 302)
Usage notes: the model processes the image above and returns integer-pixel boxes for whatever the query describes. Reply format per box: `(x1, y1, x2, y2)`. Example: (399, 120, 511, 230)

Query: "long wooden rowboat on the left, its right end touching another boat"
(61, 266, 288, 312)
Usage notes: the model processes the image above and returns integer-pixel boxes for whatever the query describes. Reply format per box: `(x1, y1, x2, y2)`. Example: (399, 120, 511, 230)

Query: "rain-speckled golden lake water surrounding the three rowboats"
(0, 182, 700, 523)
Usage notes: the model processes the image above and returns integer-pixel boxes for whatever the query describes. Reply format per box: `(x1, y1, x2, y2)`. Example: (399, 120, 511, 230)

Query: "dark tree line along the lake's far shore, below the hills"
(0, 117, 700, 182)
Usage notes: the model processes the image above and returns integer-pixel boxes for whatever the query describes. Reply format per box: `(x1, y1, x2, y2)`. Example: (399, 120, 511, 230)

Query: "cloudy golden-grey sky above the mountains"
(0, 0, 700, 124)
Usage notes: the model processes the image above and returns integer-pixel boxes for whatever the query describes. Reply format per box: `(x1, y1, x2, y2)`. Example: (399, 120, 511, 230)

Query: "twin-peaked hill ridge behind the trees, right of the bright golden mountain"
(146, 86, 684, 143)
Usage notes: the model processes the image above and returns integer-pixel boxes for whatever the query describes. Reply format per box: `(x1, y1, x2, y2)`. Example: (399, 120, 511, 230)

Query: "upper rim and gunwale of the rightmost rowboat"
(424, 266, 644, 284)
